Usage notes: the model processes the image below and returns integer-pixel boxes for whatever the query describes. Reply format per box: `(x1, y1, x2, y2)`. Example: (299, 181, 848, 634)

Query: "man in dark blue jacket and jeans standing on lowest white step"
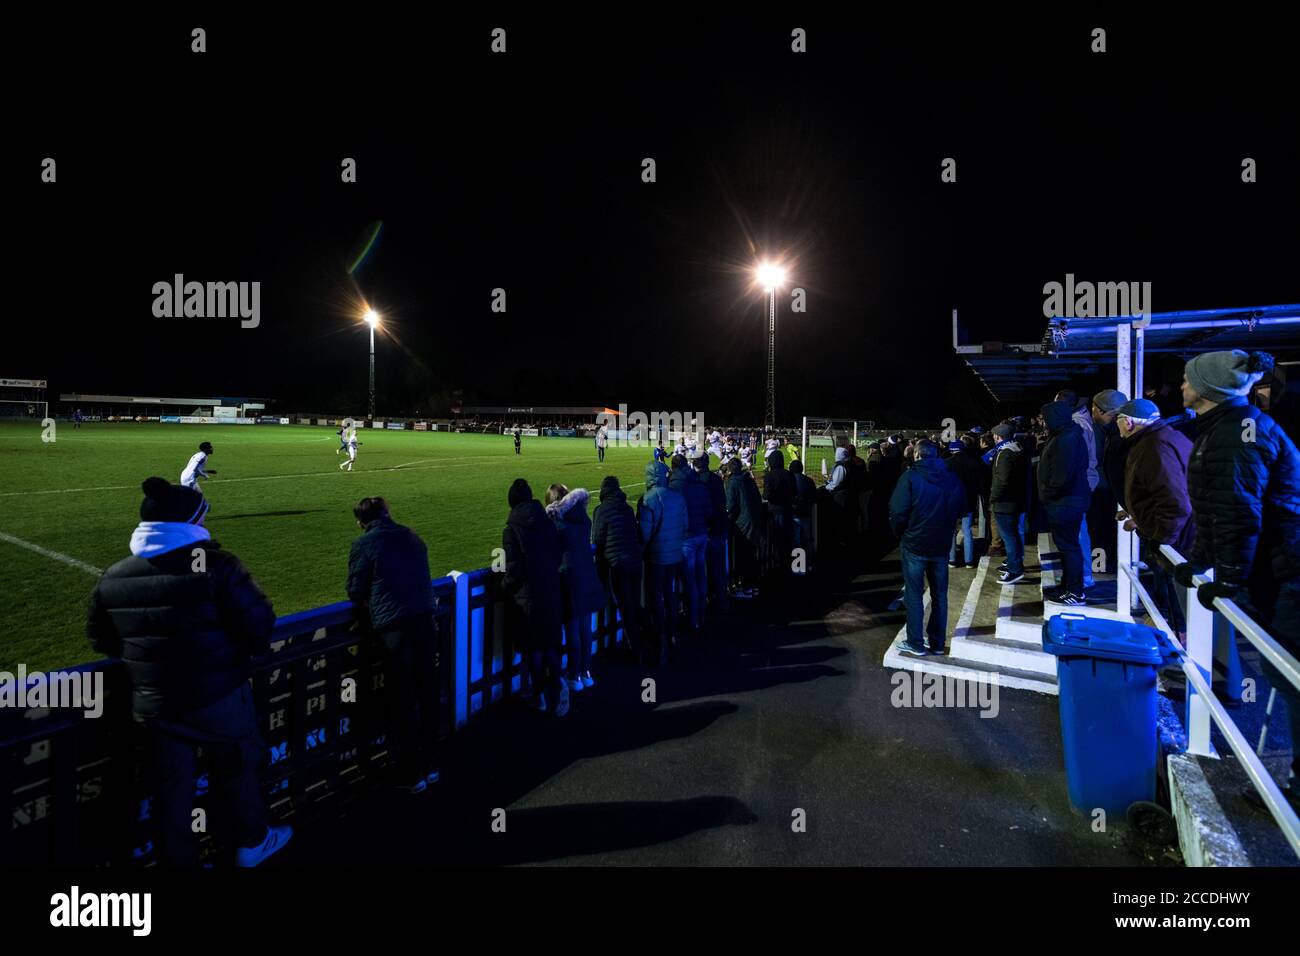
(889, 440, 967, 657)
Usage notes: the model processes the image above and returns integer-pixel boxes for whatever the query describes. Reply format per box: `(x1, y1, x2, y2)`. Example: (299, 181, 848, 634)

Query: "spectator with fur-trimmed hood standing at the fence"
(546, 484, 605, 691)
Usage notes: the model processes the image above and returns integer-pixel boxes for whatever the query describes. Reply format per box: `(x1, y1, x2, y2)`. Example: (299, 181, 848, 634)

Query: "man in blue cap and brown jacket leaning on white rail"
(1117, 398, 1196, 640)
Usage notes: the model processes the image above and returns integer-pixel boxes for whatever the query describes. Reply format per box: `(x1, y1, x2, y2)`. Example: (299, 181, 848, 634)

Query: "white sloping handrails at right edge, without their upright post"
(1119, 545, 1300, 856)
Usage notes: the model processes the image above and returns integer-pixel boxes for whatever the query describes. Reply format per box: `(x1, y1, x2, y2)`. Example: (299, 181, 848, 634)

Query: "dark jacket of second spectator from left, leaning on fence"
(347, 518, 433, 631)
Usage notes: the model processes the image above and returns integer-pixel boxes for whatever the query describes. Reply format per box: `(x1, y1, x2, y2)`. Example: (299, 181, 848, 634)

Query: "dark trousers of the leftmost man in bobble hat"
(144, 683, 268, 866)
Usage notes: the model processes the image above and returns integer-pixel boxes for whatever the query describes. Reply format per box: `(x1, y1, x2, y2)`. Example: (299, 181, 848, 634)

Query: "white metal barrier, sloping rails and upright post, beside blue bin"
(1119, 545, 1300, 855)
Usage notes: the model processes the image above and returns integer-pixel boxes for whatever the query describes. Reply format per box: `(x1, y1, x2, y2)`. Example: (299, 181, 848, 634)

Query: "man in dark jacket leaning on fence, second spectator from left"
(347, 498, 439, 793)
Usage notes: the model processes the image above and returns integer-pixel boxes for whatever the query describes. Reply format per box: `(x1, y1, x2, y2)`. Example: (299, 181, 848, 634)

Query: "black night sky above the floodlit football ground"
(12, 7, 1300, 424)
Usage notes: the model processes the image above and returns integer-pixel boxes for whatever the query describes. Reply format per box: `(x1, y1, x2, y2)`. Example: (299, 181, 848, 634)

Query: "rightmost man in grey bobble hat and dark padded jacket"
(1174, 350, 1300, 803)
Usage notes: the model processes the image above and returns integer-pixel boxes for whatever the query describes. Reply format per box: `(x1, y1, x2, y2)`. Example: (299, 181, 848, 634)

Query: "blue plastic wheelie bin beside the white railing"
(1043, 614, 1169, 818)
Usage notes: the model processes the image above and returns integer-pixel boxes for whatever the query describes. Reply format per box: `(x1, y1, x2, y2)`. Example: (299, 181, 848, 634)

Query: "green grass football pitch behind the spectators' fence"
(0, 423, 650, 671)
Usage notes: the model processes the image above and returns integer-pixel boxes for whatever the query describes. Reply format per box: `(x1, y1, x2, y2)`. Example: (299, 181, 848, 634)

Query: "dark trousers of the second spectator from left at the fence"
(378, 617, 441, 783)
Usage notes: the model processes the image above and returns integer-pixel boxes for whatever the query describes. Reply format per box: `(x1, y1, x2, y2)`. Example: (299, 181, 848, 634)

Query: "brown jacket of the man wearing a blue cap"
(1118, 421, 1196, 557)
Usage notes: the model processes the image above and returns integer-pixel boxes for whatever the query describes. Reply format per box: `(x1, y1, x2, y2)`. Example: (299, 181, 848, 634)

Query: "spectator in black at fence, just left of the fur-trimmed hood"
(501, 479, 569, 717)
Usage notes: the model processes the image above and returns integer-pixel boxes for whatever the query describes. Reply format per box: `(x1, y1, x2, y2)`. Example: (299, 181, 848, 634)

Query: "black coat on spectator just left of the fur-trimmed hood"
(501, 501, 564, 652)
